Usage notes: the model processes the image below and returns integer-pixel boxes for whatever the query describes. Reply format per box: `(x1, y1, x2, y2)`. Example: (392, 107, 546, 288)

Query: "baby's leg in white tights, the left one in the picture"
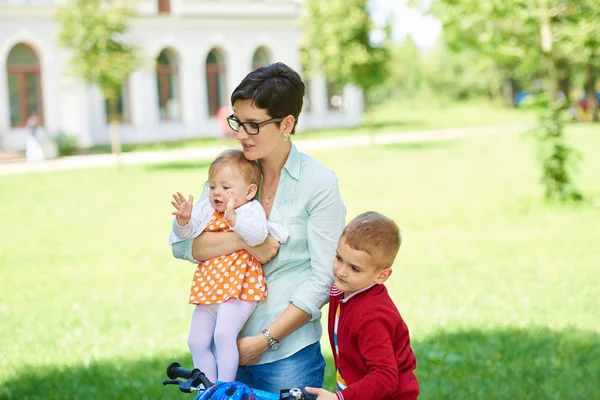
(188, 305, 217, 382)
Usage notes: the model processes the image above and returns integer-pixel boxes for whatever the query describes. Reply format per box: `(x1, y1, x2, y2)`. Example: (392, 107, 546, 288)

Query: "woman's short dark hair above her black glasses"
(231, 62, 305, 133)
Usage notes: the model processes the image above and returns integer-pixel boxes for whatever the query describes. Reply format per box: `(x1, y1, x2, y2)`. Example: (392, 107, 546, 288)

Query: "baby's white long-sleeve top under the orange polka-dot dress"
(169, 198, 289, 246)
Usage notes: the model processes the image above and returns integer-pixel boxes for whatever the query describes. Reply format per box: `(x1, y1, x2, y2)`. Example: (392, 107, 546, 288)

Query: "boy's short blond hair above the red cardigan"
(341, 211, 402, 269)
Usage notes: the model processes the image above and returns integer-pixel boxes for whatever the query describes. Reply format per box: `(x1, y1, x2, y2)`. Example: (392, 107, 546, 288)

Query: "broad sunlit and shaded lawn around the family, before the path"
(0, 126, 600, 399)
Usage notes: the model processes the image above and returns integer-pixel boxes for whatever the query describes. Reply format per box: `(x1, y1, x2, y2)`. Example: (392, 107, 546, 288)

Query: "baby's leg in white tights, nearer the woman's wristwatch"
(215, 299, 256, 382)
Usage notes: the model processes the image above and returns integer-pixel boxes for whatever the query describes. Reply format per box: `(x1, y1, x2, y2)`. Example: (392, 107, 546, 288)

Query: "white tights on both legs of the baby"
(188, 299, 256, 382)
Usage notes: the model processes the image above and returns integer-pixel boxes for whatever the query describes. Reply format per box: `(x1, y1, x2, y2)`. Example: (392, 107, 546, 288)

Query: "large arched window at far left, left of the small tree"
(6, 43, 43, 126)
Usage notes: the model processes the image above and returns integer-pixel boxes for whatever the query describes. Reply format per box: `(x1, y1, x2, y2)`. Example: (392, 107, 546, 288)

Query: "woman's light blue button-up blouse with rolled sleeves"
(173, 144, 346, 364)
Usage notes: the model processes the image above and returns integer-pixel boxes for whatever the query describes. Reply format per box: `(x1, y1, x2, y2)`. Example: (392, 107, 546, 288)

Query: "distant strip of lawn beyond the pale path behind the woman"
(80, 100, 535, 153)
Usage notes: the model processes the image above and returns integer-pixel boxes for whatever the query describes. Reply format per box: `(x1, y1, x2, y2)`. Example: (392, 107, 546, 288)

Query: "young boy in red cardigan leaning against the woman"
(306, 212, 419, 400)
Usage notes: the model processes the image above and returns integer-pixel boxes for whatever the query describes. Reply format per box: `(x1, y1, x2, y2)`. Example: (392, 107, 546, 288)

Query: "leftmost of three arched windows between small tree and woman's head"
(156, 49, 181, 121)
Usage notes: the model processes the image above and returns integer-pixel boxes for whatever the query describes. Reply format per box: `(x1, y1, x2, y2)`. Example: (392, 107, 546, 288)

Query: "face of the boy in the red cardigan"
(333, 236, 392, 296)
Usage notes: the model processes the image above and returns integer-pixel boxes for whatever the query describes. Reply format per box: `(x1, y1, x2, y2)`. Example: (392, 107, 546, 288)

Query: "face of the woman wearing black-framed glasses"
(233, 100, 294, 161)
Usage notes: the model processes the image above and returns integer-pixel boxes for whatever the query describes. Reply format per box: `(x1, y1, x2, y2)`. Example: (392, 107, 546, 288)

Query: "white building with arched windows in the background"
(0, 0, 363, 150)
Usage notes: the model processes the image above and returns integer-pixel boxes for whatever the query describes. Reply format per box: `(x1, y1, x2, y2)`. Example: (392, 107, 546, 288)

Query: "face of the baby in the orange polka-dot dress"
(208, 165, 252, 212)
